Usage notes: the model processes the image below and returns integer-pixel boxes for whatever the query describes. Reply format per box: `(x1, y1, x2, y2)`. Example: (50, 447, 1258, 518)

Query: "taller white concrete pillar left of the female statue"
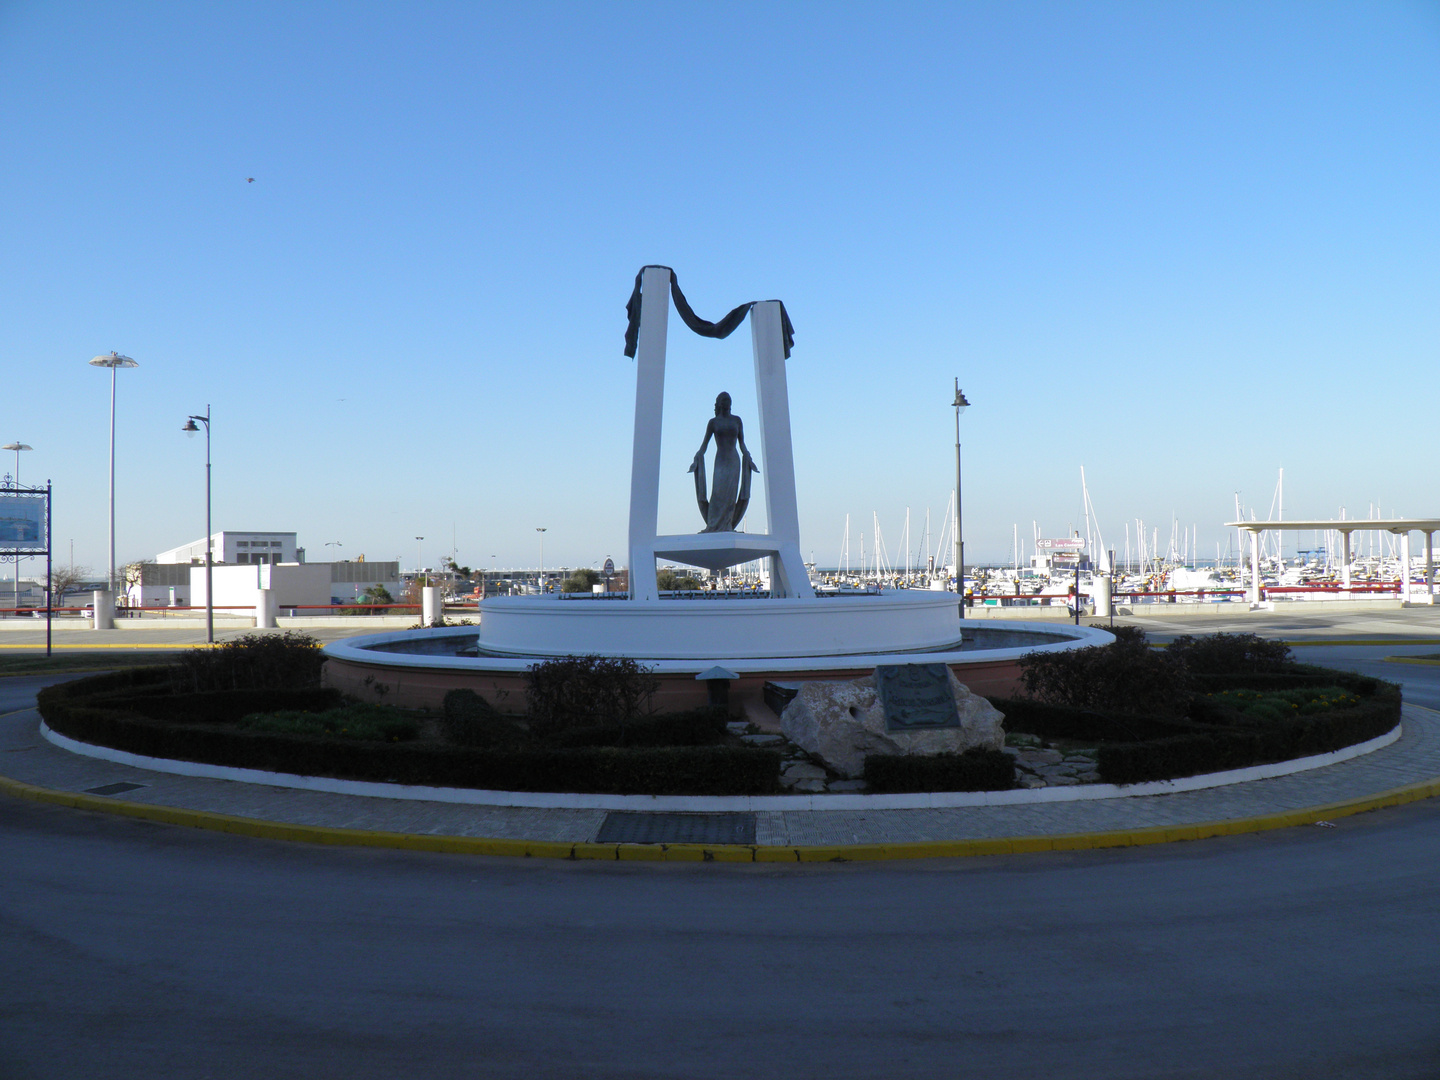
(629, 266, 671, 600)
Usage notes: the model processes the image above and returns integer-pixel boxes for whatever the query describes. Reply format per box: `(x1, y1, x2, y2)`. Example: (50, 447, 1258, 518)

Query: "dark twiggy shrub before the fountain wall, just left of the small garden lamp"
(528, 655, 660, 737)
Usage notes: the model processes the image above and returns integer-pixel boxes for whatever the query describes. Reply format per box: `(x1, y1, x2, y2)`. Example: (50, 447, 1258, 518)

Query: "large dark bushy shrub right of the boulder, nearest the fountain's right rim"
(1020, 628, 1189, 716)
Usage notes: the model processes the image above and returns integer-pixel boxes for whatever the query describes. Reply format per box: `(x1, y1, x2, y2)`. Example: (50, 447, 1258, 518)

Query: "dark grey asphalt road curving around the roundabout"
(0, 613, 1440, 1080)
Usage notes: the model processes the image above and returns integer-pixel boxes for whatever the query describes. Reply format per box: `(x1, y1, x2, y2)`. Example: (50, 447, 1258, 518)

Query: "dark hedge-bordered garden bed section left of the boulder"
(39, 639, 780, 795)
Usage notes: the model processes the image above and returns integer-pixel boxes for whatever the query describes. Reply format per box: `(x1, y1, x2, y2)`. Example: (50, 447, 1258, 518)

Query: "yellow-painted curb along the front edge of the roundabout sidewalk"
(0, 776, 1440, 863)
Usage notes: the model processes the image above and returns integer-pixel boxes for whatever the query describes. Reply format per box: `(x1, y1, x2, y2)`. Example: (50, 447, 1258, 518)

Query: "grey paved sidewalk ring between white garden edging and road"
(0, 688, 1440, 861)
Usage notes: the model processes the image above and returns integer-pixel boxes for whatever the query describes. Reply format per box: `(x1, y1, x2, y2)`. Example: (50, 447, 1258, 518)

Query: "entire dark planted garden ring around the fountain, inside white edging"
(30, 634, 1401, 795)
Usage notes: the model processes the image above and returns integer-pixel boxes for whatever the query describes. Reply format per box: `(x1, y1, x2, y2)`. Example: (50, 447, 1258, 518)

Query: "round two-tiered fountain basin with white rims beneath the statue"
(324, 590, 1113, 713)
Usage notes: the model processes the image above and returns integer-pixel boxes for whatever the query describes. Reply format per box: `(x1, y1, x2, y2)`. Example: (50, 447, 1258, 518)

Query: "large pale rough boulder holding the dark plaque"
(780, 671, 1005, 778)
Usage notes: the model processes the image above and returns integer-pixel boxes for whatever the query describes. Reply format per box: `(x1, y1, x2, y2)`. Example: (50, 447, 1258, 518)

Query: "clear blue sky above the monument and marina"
(0, 3, 1440, 578)
